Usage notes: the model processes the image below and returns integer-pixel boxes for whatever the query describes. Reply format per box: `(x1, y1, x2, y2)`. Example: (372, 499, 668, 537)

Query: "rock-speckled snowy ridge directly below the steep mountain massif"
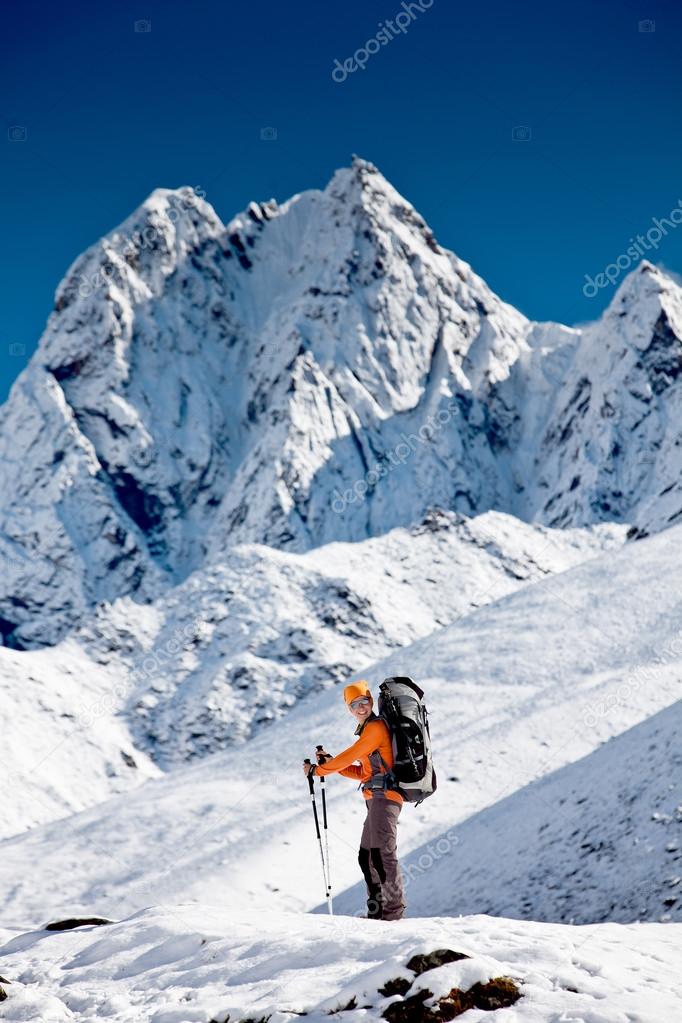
(0, 513, 624, 836)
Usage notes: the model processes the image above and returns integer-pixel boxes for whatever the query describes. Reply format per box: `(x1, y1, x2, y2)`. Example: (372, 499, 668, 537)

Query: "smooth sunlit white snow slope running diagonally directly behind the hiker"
(0, 528, 682, 926)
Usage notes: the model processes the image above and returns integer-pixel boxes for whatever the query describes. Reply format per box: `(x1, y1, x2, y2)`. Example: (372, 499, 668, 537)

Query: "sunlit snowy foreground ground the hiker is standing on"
(0, 904, 682, 1023)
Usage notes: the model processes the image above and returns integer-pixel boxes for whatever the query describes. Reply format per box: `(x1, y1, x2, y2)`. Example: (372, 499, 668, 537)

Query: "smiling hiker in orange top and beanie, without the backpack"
(304, 679, 405, 920)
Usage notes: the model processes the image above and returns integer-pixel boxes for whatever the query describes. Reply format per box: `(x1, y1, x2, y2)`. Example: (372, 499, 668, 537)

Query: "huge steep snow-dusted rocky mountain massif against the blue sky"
(0, 159, 682, 647)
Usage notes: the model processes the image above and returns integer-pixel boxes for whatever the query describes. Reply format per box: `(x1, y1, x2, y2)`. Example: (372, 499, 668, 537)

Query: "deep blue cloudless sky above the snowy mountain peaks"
(0, 0, 682, 400)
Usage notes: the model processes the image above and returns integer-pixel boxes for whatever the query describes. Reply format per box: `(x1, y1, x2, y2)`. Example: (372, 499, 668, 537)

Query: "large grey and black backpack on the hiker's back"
(378, 676, 437, 804)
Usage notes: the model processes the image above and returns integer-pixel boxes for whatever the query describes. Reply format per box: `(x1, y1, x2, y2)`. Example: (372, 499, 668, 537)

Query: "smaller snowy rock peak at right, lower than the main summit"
(497, 260, 682, 535)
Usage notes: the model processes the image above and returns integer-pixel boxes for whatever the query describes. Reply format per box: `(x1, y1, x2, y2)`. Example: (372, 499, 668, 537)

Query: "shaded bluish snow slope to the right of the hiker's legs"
(337, 703, 682, 928)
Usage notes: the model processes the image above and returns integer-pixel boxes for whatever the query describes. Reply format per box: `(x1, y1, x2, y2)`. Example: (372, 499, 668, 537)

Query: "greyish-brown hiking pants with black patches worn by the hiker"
(358, 791, 405, 920)
